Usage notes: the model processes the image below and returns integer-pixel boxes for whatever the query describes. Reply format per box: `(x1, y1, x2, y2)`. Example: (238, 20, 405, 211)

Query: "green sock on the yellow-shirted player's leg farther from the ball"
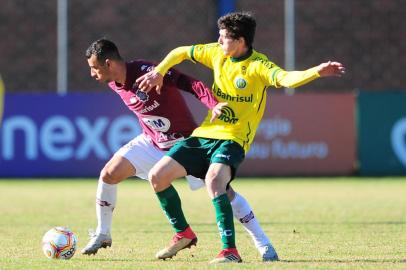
(212, 194, 235, 248)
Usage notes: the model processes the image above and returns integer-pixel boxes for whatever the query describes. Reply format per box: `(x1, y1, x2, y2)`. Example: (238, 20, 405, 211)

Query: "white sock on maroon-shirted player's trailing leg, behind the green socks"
(231, 192, 270, 248)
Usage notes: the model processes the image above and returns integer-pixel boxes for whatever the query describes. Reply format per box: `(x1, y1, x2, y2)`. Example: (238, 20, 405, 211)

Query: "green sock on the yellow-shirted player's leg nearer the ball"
(156, 185, 189, 232)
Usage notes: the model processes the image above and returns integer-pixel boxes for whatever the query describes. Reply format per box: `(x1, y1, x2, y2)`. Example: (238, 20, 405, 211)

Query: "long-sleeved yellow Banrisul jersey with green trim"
(156, 43, 319, 153)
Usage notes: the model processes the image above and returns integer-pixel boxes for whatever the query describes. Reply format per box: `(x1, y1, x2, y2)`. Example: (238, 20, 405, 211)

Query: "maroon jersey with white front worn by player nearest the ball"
(109, 60, 217, 150)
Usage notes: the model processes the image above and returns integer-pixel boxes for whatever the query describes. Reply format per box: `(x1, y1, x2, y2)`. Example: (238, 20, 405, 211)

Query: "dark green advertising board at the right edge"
(357, 91, 406, 175)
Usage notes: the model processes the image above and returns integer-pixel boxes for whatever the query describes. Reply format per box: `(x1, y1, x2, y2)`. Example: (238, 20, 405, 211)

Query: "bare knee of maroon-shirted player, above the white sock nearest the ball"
(101, 155, 135, 184)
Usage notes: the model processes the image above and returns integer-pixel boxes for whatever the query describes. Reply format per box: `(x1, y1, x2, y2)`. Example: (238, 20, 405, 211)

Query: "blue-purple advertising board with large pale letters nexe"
(0, 92, 140, 177)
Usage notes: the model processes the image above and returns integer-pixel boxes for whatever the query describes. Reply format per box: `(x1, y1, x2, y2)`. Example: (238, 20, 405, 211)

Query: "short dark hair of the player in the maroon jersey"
(86, 38, 122, 63)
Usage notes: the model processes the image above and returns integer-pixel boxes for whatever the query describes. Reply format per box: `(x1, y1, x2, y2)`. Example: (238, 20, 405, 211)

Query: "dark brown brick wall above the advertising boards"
(0, 0, 406, 92)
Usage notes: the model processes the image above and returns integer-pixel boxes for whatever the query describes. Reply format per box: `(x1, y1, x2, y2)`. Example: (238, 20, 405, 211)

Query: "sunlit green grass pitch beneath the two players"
(0, 178, 406, 270)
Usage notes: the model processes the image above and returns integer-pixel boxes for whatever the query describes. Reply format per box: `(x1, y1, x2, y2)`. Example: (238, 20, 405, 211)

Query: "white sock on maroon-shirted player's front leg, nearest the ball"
(96, 179, 117, 234)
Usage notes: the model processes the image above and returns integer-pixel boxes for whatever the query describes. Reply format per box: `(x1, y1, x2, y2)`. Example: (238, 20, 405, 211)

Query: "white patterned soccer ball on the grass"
(42, 227, 77, 260)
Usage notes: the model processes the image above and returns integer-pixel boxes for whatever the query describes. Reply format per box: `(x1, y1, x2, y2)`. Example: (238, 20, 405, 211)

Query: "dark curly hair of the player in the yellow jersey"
(217, 12, 257, 47)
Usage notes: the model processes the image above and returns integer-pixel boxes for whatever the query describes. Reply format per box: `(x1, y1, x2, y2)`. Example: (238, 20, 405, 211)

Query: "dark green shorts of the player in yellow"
(166, 137, 245, 181)
